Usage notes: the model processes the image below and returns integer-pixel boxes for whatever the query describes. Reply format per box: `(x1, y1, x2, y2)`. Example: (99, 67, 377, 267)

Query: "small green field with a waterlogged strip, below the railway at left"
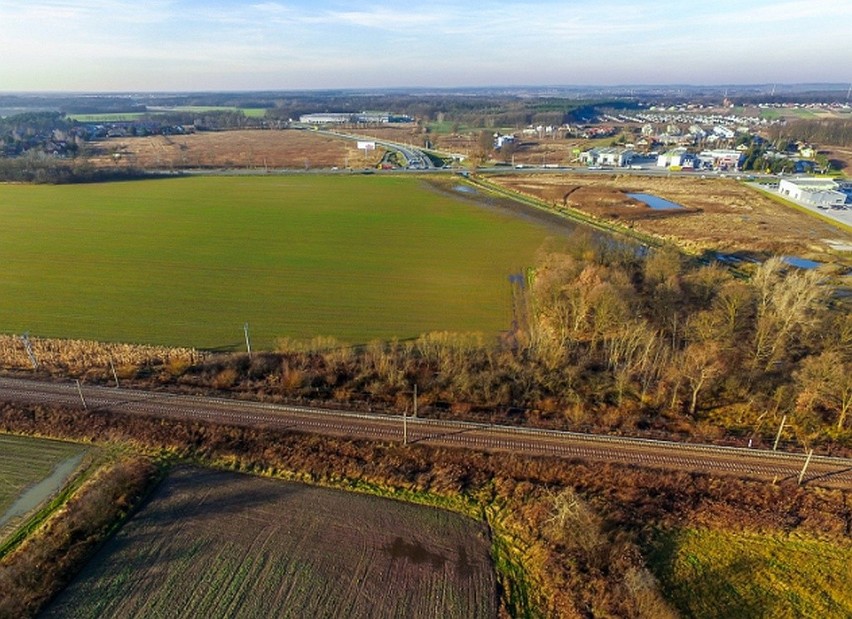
(0, 434, 85, 538)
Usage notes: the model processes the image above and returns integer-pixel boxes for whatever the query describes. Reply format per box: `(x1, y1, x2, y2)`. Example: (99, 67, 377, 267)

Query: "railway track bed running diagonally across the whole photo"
(5, 378, 852, 490)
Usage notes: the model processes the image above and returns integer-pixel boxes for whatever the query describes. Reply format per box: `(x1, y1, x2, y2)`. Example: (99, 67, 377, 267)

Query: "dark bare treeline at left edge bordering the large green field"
(0, 153, 149, 184)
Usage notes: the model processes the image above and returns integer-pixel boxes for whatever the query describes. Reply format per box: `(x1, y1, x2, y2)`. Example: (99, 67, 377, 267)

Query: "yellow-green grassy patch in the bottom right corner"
(650, 529, 852, 619)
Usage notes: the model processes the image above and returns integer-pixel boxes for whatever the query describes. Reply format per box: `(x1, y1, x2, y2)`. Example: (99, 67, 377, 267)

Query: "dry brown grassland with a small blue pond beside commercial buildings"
(492, 174, 852, 263)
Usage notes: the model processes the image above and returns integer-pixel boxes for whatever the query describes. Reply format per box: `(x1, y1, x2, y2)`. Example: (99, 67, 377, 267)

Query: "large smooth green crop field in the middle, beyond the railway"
(0, 175, 564, 348)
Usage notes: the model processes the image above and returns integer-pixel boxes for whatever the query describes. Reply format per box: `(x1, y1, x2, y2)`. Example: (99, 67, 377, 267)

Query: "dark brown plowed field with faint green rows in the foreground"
(44, 469, 497, 618)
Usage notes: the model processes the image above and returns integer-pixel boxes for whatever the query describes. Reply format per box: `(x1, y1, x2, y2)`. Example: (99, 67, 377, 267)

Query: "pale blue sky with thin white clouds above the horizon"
(0, 0, 852, 92)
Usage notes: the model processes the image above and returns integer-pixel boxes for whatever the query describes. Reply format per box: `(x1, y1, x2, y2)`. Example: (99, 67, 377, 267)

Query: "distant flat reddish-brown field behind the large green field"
(90, 130, 383, 169)
